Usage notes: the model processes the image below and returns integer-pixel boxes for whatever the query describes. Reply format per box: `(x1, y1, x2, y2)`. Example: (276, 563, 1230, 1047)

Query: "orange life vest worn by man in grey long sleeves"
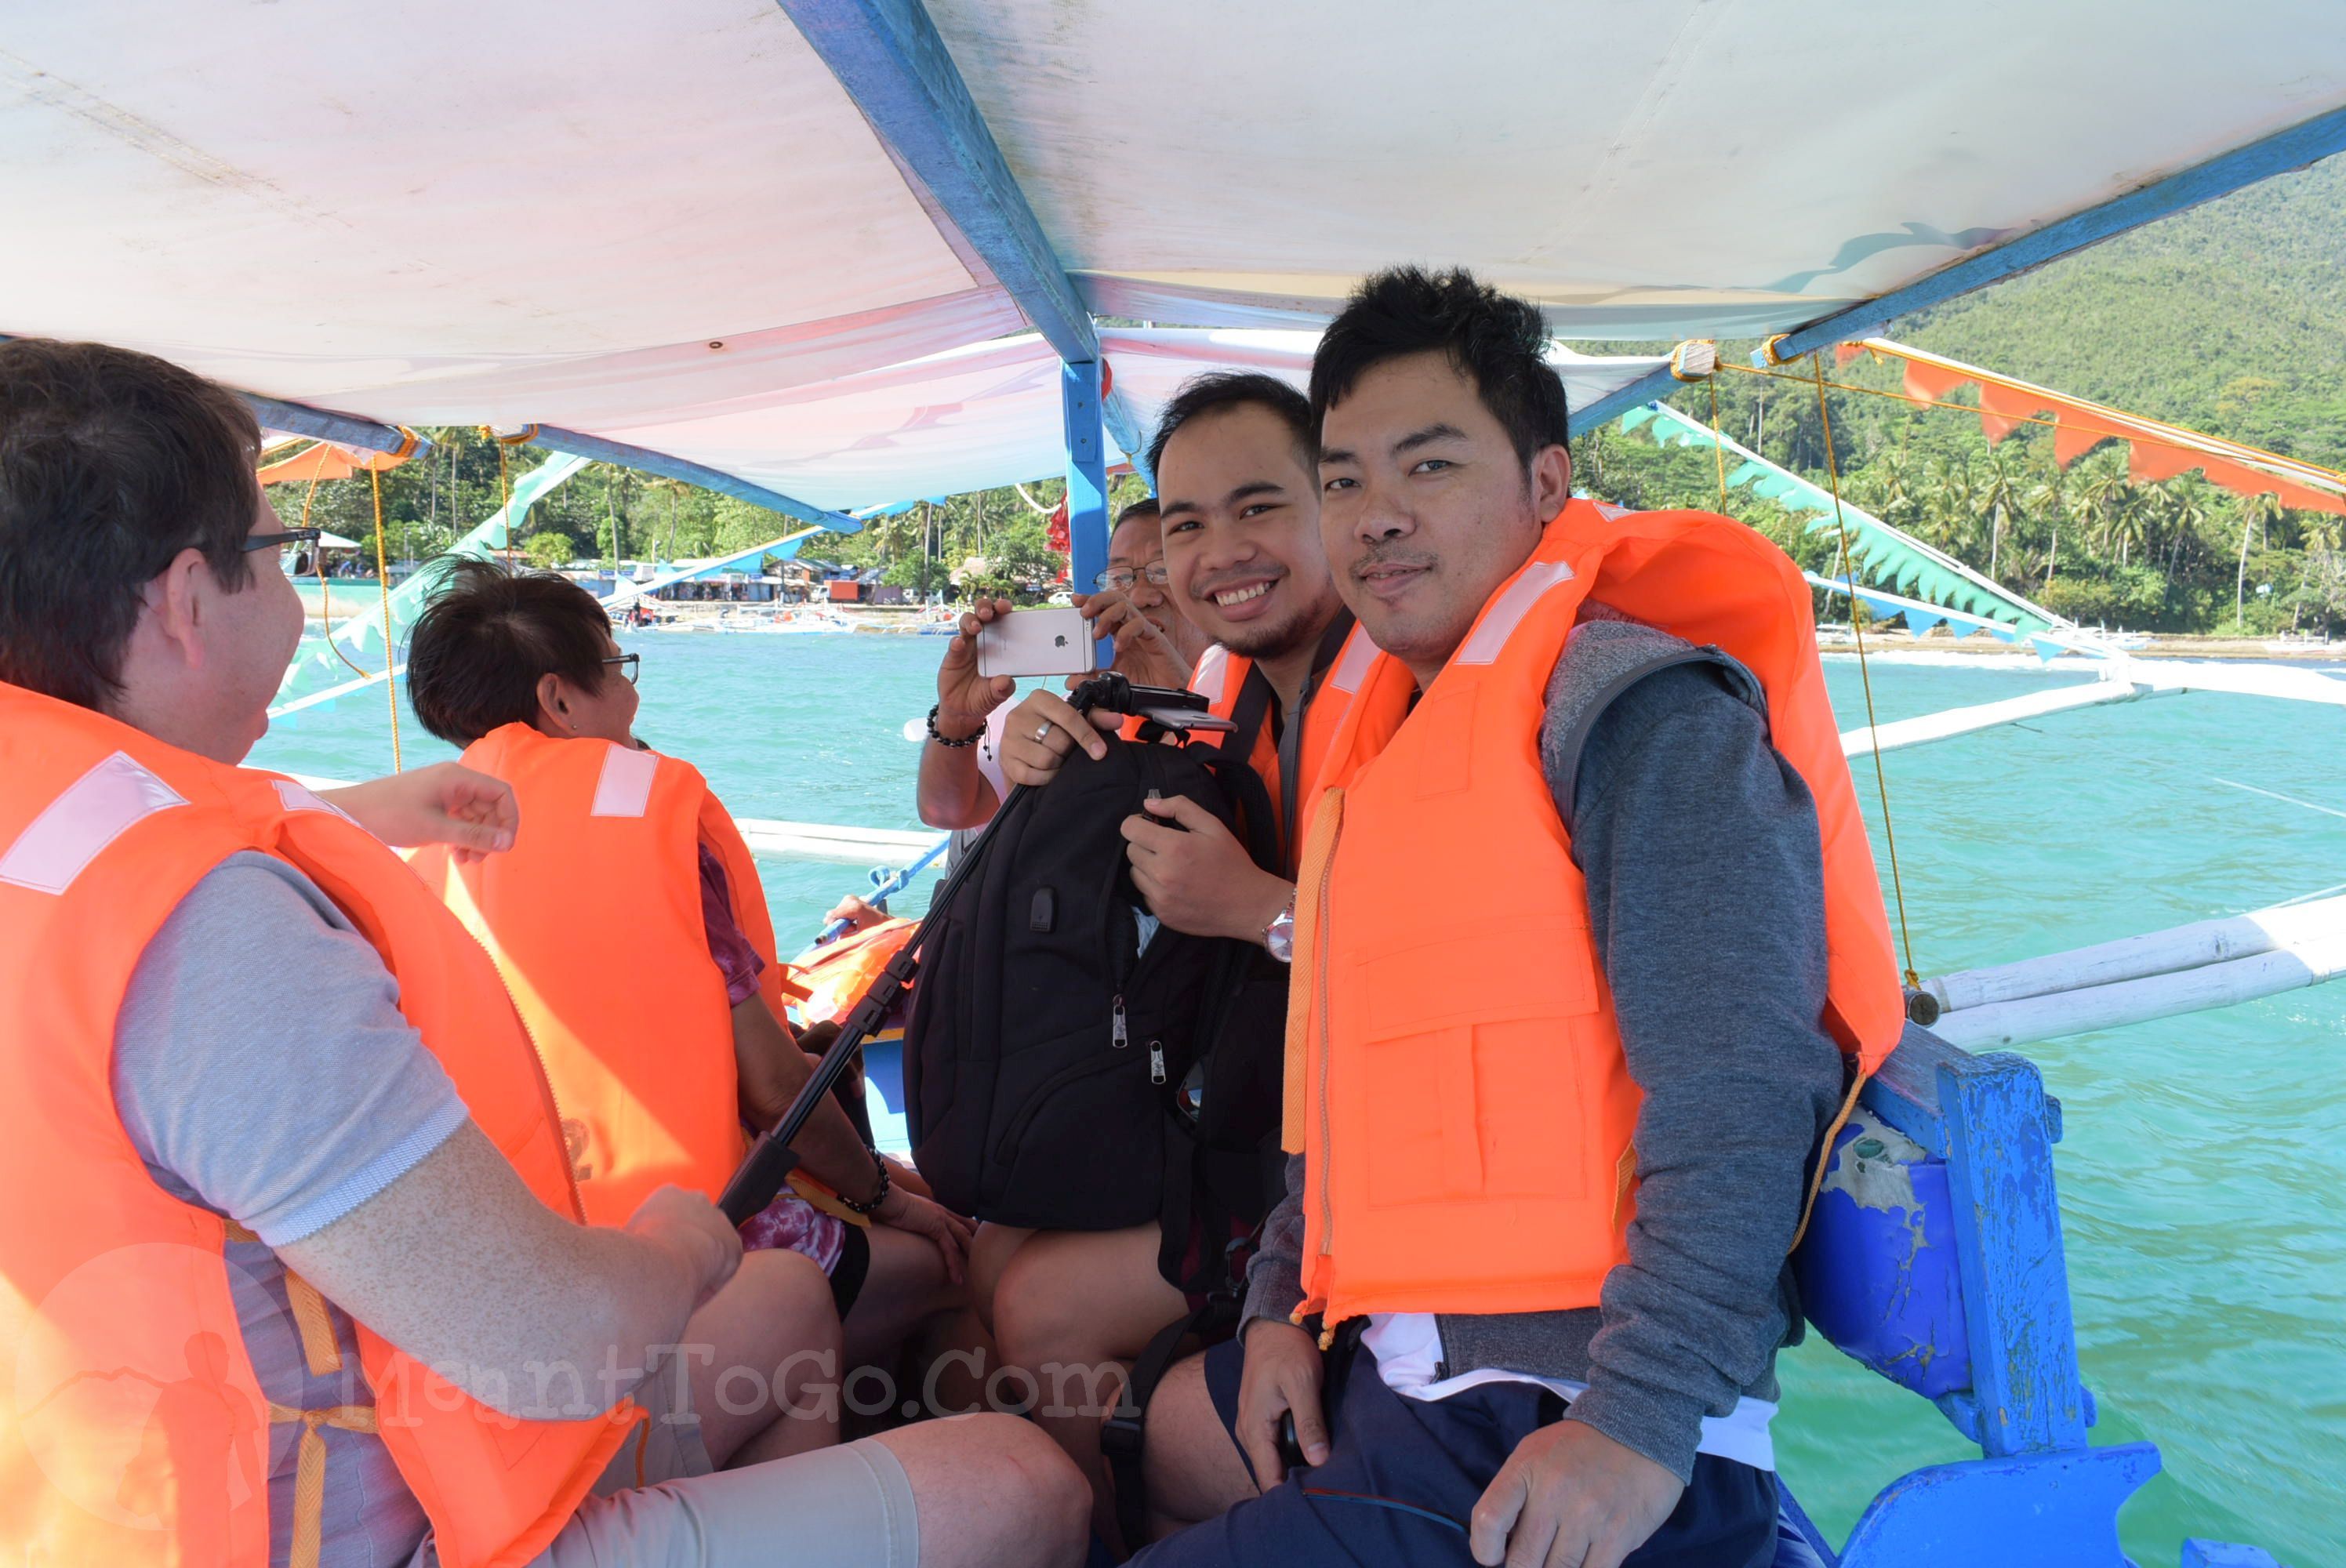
(1286, 500, 1903, 1327)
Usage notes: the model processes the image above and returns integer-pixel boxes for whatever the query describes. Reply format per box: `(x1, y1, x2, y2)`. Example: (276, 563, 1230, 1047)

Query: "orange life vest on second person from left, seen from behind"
(411, 723, 804, 1225)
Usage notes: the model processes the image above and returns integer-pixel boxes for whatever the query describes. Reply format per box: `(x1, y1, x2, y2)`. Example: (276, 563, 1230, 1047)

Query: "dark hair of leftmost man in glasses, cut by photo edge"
(0, 338, 260, 709)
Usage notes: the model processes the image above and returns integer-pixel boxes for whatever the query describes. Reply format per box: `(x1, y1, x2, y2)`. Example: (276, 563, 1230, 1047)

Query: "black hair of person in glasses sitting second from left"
(409, 559, 610, 746)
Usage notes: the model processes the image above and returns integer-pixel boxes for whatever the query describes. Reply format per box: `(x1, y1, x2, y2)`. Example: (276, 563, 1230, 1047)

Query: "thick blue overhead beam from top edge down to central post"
(776, 0, 1149, 483)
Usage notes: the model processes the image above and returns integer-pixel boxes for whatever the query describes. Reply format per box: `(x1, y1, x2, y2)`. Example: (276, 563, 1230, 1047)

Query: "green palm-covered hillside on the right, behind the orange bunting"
(1579, 158, 2346, 633)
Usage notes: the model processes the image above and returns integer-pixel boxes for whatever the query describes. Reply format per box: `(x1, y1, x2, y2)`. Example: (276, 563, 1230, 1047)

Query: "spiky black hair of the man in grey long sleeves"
(1312, 267, 1572, 467)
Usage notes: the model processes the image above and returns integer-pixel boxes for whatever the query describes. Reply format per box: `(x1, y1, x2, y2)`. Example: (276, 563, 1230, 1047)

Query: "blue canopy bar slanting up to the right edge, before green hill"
(1572, 108, 2346, 434)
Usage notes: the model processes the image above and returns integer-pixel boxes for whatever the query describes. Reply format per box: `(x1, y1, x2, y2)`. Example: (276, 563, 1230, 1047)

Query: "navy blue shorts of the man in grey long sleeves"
(1133, 1341, 1776, 1568)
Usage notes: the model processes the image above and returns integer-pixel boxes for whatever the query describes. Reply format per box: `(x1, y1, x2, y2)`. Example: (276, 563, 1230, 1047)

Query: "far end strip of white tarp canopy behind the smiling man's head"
(608, 326, 1663, 512)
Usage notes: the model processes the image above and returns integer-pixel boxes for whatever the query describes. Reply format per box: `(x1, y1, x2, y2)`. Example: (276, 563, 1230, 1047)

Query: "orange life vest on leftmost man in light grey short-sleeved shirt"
(0, 683, 641, 1568)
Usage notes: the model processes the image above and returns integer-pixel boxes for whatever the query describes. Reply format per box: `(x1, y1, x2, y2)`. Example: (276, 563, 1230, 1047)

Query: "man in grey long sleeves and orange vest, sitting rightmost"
(1147, 267, 1903, 1568)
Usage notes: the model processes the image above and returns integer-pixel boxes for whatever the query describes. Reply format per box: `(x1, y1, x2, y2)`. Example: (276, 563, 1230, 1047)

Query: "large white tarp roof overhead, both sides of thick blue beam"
(0, 0, 2346, 498)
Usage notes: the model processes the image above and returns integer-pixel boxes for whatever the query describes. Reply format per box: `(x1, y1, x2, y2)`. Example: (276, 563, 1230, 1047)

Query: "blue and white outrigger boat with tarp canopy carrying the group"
(0, 0, 2346, 1568)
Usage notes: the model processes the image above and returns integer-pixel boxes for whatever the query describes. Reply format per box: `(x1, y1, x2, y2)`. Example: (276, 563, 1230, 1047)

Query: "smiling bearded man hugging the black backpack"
(979, 373, 1375, 1544)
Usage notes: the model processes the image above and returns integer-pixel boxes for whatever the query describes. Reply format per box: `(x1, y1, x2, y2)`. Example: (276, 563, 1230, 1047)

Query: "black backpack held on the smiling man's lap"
(903, 737, 1286, 1239)
